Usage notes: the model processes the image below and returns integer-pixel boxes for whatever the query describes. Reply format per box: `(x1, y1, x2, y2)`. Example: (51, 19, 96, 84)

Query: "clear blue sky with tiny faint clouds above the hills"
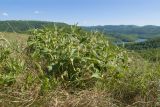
(0, 0, 160, 26)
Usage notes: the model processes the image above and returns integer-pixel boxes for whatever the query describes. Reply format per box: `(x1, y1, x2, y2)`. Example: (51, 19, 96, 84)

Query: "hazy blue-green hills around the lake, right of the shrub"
(83, 25, 160, 42)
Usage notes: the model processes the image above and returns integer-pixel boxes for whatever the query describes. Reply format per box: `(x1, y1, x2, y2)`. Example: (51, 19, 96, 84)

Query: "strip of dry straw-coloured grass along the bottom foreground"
(0, 86, 159, 107)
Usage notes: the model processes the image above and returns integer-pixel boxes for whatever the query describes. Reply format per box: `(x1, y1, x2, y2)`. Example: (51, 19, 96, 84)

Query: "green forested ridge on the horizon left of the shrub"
(0, 20, 67, 32)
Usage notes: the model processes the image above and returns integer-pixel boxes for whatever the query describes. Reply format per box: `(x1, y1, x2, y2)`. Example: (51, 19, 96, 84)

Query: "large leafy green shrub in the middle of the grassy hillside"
(27, 26, 128, 88)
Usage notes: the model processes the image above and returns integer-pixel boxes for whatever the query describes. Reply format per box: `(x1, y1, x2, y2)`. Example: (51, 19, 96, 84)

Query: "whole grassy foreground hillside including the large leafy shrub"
(0, 26, 160, 107)
